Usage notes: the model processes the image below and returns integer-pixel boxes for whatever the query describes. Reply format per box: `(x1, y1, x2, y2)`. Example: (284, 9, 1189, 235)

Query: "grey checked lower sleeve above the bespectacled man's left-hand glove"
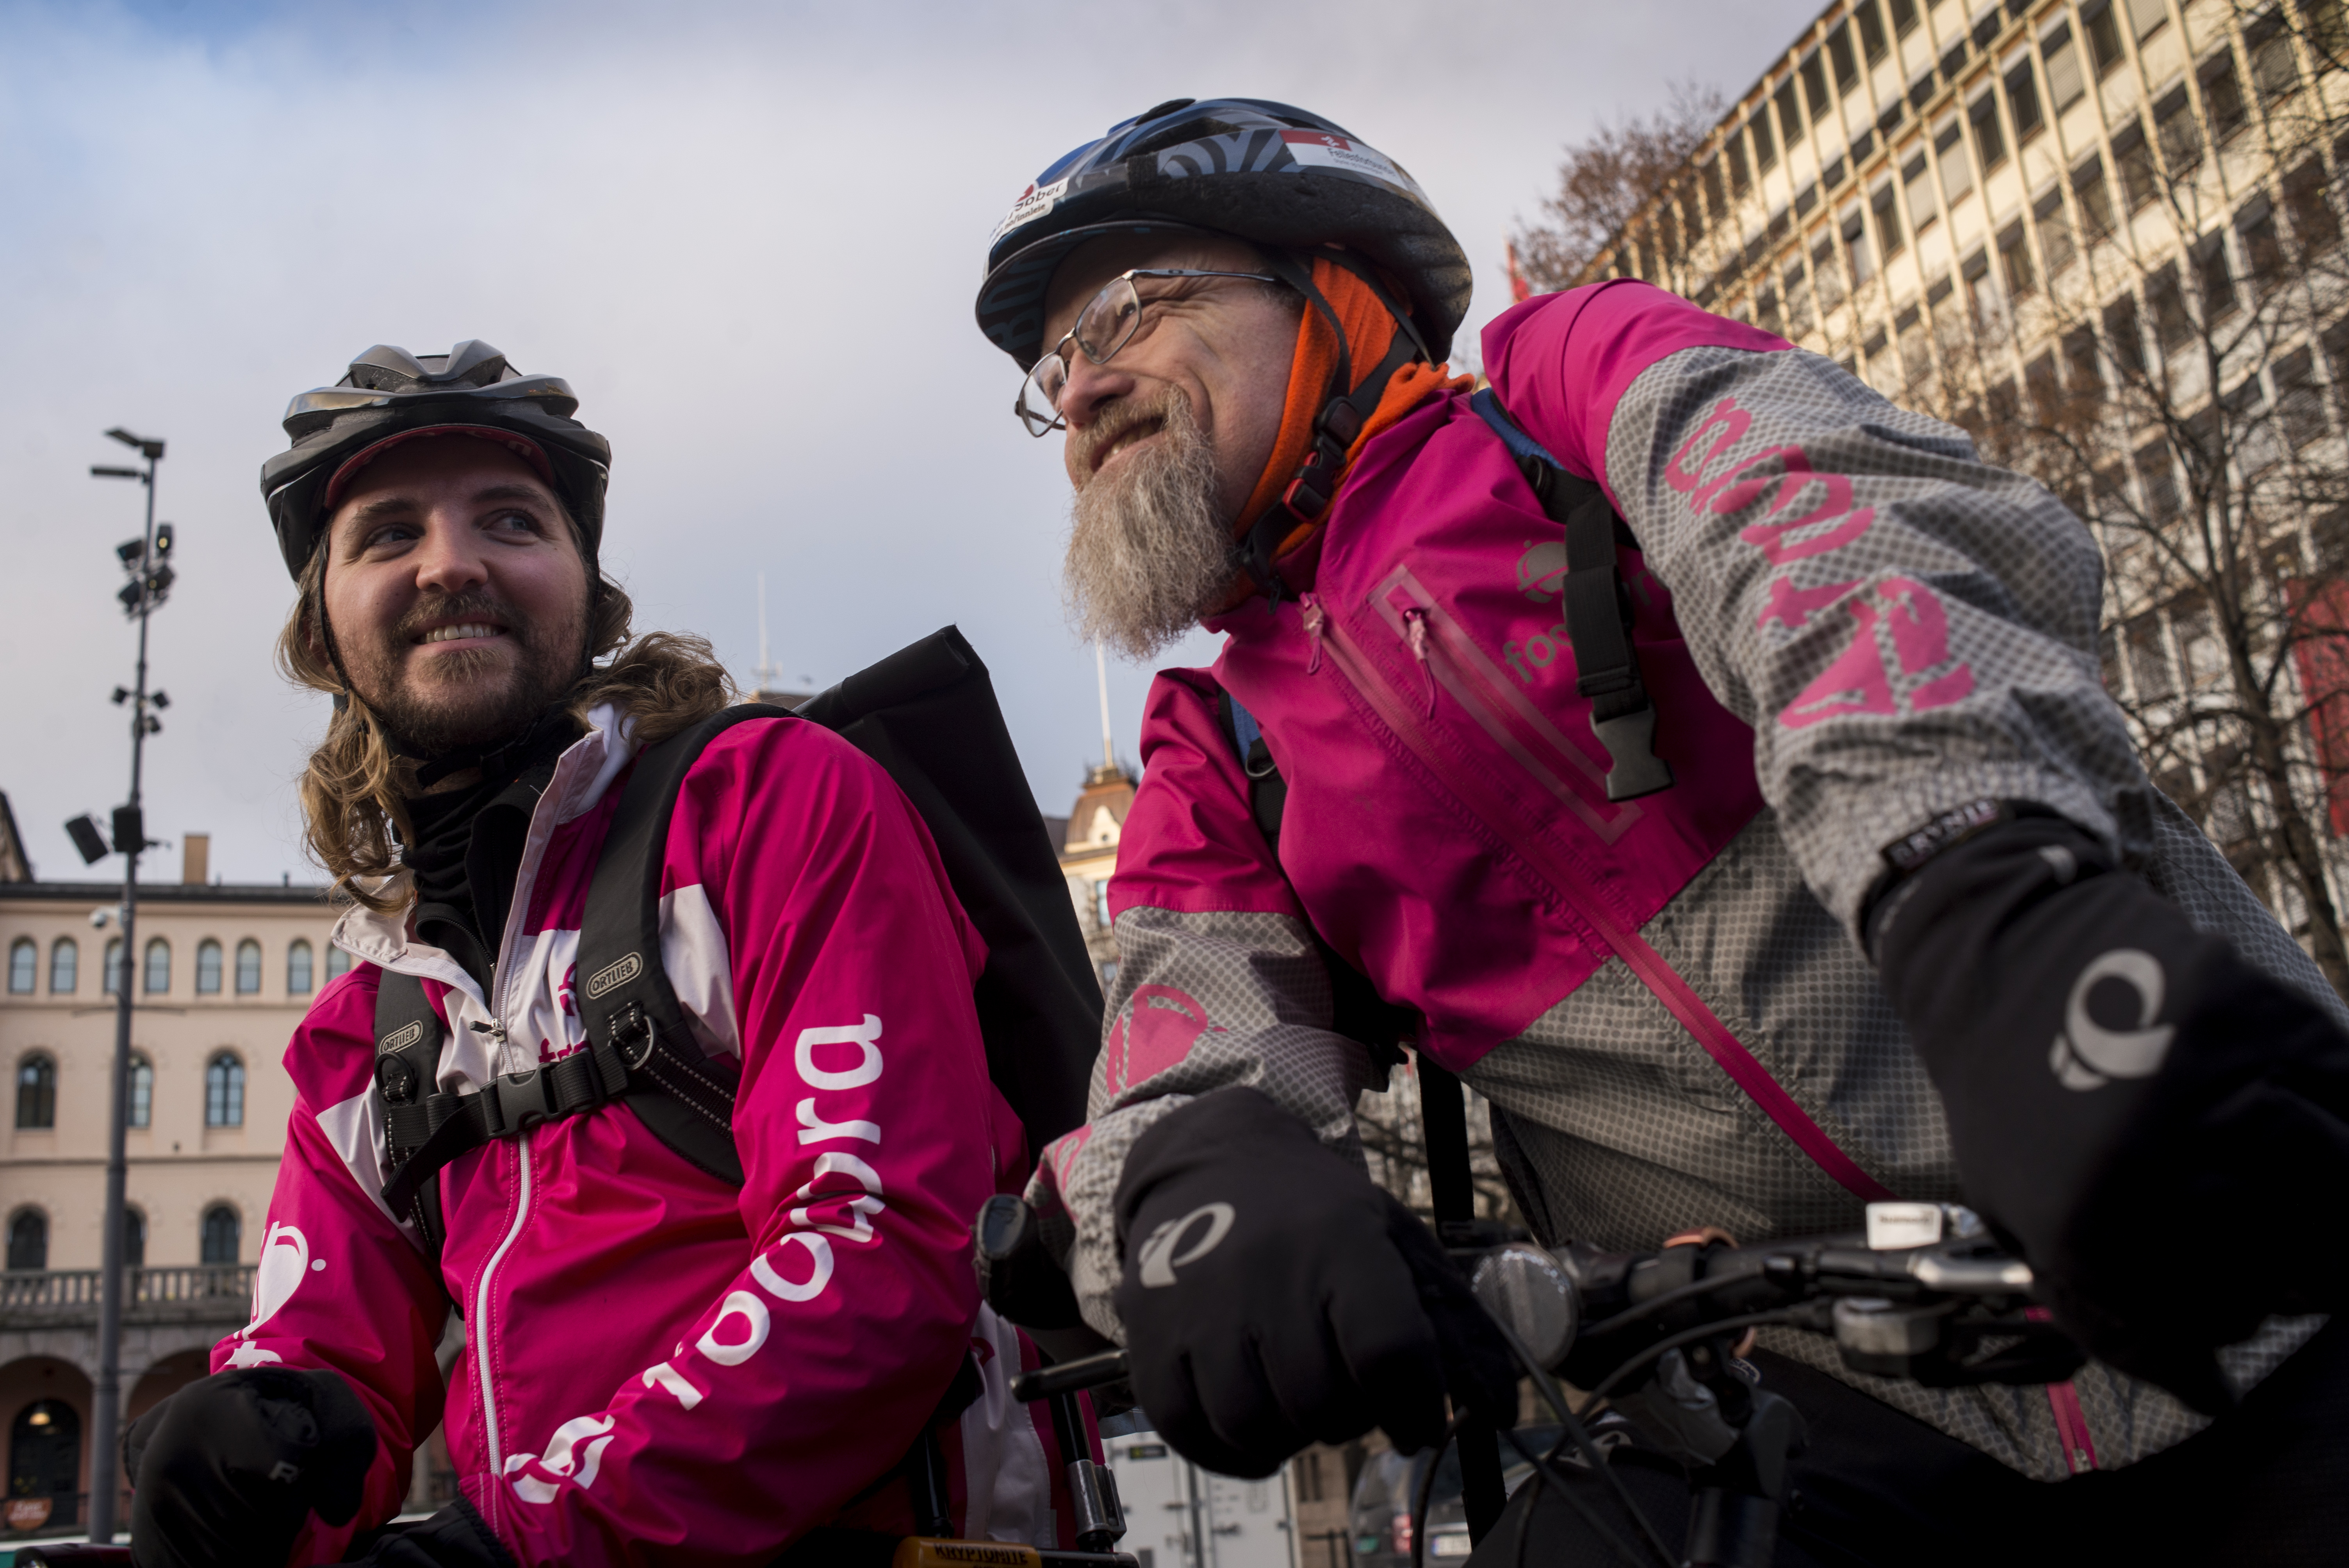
(1027, 906, 1369, 1343)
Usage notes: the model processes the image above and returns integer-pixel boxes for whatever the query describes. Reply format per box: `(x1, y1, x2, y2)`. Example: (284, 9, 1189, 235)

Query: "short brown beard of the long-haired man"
(336, 592, 587, 761)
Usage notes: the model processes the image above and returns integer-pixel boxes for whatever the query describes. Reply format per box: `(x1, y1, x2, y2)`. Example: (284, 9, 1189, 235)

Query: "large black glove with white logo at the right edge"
(1872, 817, 2349, 1411)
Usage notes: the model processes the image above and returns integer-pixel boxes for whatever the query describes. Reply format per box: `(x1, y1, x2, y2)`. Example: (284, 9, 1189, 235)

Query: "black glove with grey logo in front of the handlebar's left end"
(1116, 1089, 1517, 1477)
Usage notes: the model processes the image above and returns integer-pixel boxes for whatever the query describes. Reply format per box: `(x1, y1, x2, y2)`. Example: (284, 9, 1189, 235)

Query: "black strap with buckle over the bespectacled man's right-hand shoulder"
(1468, 387, 1672, 800)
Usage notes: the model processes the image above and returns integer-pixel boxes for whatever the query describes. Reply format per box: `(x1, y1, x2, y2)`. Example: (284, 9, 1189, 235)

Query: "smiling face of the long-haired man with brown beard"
(324, 434, 587, 758)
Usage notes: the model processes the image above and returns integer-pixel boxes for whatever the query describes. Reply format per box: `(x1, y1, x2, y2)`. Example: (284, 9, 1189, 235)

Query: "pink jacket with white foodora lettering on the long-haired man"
(211, 714, 1069, 1563)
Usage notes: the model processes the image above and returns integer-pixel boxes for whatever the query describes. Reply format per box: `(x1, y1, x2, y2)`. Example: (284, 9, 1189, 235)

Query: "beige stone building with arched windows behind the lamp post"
(0, 821, 343, 1528)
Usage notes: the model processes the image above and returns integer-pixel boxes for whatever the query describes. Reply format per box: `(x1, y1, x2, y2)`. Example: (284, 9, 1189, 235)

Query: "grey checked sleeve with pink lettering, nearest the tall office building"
(1607, 347, 2149, 930)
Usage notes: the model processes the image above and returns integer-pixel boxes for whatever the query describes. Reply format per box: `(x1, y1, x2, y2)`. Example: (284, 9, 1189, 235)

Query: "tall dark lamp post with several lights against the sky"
(75, 427, 171, 1542)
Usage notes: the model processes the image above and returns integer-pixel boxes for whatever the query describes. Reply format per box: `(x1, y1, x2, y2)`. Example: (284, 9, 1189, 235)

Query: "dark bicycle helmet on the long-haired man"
(261, 338, 611, 582)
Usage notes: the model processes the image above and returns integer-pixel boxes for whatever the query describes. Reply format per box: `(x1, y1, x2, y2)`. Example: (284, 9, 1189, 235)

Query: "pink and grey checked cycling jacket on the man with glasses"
(1029, 282, 2349, 1479)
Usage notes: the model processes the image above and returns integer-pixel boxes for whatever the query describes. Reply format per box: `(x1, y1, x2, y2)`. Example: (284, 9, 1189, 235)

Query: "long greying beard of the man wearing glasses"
(1062, 387, 1235, 659)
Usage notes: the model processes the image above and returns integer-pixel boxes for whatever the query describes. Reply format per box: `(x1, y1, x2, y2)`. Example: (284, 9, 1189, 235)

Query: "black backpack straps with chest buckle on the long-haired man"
(376, 704, 789, 1221)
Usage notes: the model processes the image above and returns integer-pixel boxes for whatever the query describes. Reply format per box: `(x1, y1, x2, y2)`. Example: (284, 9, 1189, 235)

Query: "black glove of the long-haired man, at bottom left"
(122, 1366, 376, 1568)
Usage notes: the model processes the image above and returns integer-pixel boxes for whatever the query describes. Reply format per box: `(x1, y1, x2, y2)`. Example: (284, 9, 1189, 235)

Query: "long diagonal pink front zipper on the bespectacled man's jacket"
(1299, 594, 1893, 1199)
